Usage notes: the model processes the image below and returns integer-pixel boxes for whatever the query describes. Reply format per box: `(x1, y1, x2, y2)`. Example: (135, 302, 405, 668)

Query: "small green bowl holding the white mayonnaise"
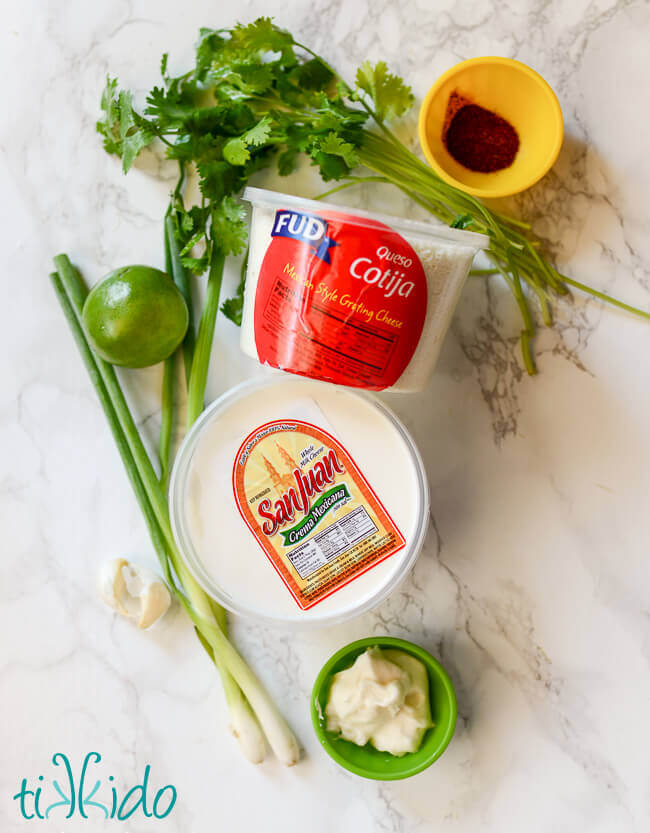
(311, 636, 457, 781)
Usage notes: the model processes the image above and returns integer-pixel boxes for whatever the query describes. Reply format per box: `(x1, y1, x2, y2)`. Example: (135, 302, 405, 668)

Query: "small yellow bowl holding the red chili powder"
(418, 57, 564, 198)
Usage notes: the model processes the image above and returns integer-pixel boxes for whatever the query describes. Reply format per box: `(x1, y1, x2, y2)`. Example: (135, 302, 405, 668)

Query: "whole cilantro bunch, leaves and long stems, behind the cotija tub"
(97, 17, 650, 373)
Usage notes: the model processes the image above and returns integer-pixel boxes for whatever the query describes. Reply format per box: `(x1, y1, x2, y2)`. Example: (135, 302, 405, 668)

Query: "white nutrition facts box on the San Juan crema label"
(287, 506, 377, 579)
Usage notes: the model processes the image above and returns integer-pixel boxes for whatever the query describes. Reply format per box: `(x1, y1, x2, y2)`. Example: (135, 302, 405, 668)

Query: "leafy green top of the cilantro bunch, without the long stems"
(97, 18, 413, 342)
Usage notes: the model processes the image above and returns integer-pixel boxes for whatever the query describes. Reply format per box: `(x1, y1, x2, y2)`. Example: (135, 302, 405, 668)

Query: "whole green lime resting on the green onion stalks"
(82, 266, 188, 367)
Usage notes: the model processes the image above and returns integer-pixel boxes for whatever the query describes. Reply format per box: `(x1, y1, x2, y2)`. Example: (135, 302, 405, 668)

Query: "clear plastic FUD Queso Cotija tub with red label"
(241, 188, 489, 392)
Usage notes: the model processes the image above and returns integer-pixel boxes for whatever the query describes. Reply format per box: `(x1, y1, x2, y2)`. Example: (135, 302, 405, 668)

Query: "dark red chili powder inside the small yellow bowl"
(442, 92, 519, 174)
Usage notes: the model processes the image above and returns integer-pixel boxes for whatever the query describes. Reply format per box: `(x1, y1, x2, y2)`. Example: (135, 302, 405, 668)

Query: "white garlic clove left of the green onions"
(99, 558, 171, 628)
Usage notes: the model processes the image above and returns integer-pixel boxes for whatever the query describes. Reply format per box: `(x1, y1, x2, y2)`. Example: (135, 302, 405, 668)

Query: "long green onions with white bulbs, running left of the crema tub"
(50, 255, 300, 765)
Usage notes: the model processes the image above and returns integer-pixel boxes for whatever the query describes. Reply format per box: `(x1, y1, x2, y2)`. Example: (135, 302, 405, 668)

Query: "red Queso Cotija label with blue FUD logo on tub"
(255, 209, 427, 390)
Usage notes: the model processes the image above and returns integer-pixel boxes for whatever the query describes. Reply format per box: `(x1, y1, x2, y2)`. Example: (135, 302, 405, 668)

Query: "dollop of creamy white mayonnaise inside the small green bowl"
(325, 648, 432, 756)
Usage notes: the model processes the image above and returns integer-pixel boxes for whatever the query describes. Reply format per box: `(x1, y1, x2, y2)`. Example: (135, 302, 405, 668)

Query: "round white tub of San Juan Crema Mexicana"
(170, 374, 429, 627)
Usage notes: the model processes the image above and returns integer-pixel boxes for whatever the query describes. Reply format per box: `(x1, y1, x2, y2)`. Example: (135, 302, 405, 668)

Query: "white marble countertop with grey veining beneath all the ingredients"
(0, 0, 650, 833)
